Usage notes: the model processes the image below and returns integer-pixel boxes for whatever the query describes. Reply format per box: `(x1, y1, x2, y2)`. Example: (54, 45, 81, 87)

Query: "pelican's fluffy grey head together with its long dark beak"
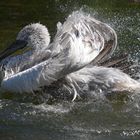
(0, 23, 50, 61)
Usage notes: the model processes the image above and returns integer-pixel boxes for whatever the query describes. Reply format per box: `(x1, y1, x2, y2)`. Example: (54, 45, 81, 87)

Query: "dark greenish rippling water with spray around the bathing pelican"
(0, 0, 140, 140)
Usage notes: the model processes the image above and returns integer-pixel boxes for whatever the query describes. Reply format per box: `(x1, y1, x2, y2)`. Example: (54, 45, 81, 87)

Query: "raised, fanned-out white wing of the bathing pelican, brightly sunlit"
(52, 11, 116, 70)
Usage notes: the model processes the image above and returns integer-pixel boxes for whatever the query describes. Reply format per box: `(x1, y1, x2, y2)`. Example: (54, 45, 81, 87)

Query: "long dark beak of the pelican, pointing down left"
(0, 40, 27, 61)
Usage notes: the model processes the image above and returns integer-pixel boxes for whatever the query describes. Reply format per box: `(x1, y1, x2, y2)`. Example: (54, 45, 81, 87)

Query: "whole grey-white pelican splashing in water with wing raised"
(0, 11, 140, 100)
